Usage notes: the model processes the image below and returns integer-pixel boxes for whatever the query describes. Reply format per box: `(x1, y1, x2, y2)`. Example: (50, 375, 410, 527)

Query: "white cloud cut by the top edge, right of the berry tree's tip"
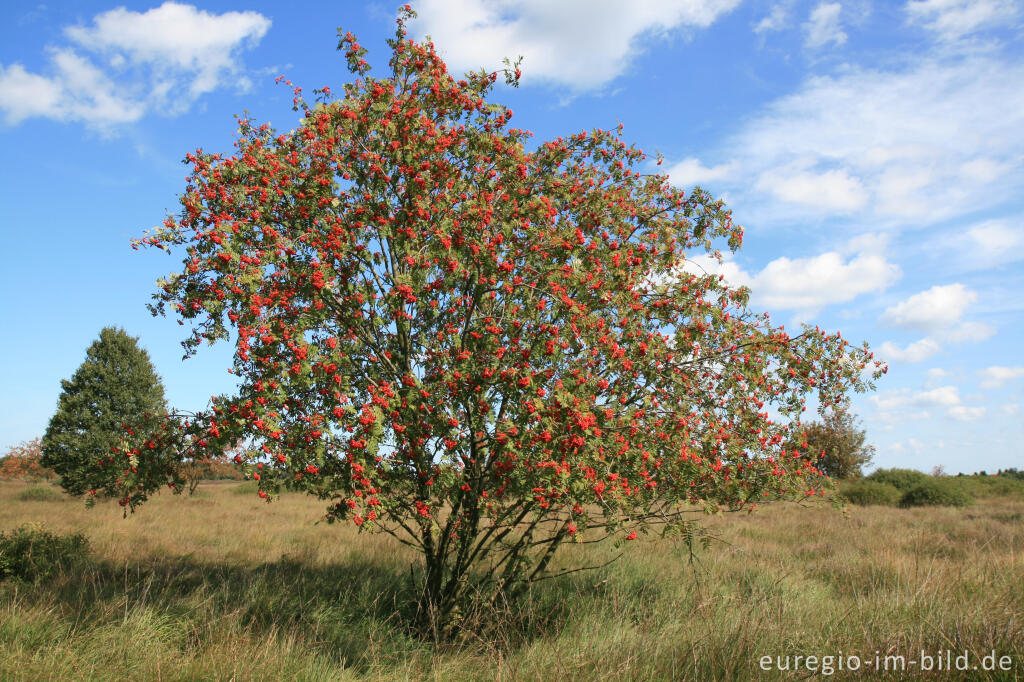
(414, 0, 738, 91)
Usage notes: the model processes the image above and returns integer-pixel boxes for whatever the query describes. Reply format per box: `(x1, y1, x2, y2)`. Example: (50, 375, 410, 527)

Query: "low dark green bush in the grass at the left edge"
(0, 524, 89, 583)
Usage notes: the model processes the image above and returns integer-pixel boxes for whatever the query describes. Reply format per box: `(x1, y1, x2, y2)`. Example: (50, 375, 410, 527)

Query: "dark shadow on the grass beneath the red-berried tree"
(6, 554, 622, 673)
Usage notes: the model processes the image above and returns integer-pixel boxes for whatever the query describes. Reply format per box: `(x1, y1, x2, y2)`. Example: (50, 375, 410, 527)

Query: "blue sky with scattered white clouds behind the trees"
(0, 0, 1024, 472)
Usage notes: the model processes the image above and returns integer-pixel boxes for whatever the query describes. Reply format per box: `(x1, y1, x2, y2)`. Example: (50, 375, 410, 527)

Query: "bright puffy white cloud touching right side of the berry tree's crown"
(687, 231, 901, 314)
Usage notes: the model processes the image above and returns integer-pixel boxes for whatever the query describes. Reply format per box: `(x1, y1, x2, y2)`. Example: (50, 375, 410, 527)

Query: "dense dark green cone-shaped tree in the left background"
(42, 327, 181, 504)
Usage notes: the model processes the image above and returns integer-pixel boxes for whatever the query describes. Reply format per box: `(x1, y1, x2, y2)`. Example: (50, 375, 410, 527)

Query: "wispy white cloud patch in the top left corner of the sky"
(0, 2, 270, 130)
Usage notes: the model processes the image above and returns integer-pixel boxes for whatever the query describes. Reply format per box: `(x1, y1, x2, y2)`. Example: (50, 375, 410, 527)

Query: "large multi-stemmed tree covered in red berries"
(123, 7, 881, 632)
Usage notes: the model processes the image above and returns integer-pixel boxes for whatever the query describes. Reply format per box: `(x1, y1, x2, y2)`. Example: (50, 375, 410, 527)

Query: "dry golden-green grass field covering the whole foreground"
(0, 482, 1024, 680)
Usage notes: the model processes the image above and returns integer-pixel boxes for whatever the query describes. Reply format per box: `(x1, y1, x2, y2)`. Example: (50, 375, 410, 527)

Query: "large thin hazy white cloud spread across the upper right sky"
(712, 51, 1024, 224)
